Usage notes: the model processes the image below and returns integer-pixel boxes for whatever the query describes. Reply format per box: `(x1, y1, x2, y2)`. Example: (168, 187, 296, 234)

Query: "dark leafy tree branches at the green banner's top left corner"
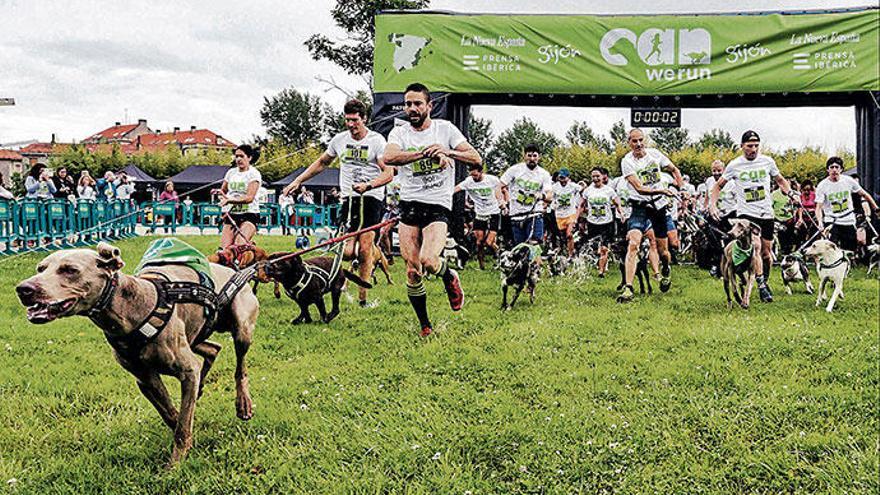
(305, 0, 430, 80)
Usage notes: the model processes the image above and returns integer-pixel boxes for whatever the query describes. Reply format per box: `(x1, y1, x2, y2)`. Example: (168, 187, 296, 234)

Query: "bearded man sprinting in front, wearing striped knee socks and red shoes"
(385, 83, 482, 337)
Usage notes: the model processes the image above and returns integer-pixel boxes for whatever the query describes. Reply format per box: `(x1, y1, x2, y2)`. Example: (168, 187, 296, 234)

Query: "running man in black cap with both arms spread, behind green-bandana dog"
(709, 131, 800, 302)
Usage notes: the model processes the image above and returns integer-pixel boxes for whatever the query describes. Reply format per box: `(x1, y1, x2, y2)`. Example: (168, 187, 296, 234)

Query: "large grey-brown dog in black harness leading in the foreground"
(16, 242, 260, 465)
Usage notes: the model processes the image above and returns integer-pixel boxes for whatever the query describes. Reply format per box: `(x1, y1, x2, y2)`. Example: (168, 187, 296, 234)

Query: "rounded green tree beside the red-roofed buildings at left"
(260, 88, 336, 148)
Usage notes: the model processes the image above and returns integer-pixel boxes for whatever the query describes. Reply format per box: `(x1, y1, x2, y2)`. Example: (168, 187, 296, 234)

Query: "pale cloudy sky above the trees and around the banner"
(0, 0, 876, 151)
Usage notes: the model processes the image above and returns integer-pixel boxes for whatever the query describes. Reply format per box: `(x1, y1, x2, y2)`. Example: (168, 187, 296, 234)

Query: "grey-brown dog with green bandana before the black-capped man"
(721, 219, 761, 309)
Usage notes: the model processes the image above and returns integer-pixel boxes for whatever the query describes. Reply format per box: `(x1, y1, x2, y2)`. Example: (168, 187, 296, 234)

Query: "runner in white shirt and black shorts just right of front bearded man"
(455, 163, 503, 270)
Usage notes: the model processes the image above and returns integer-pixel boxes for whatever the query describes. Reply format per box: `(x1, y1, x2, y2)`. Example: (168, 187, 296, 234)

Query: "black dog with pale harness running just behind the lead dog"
(257, 253, 373, 325)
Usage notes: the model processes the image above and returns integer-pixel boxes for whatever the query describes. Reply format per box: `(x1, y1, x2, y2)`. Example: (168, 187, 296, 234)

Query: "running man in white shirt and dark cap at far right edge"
(816, 156, 877, 251)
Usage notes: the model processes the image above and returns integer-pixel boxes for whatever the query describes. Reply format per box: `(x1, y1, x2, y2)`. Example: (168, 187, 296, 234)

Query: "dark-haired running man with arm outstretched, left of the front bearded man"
(282, 99, 394, 307)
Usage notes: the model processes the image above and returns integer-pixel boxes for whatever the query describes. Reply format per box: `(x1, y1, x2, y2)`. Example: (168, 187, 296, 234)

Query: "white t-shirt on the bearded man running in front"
(388, 119, 467, 210)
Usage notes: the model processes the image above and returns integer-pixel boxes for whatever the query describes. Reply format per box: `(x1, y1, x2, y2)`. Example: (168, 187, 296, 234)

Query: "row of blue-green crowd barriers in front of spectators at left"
(0, 199, 339, 254)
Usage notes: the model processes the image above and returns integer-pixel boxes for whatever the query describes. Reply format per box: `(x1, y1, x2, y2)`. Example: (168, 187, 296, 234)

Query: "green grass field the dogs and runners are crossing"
(0, 236, 880, 494)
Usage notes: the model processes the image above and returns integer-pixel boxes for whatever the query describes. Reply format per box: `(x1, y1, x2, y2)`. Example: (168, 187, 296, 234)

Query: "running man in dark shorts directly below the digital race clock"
(617, 129, 682, 302)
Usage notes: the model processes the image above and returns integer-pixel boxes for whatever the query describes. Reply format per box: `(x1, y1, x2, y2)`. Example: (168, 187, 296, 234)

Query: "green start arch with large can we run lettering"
(372, 7, 880, 239)
